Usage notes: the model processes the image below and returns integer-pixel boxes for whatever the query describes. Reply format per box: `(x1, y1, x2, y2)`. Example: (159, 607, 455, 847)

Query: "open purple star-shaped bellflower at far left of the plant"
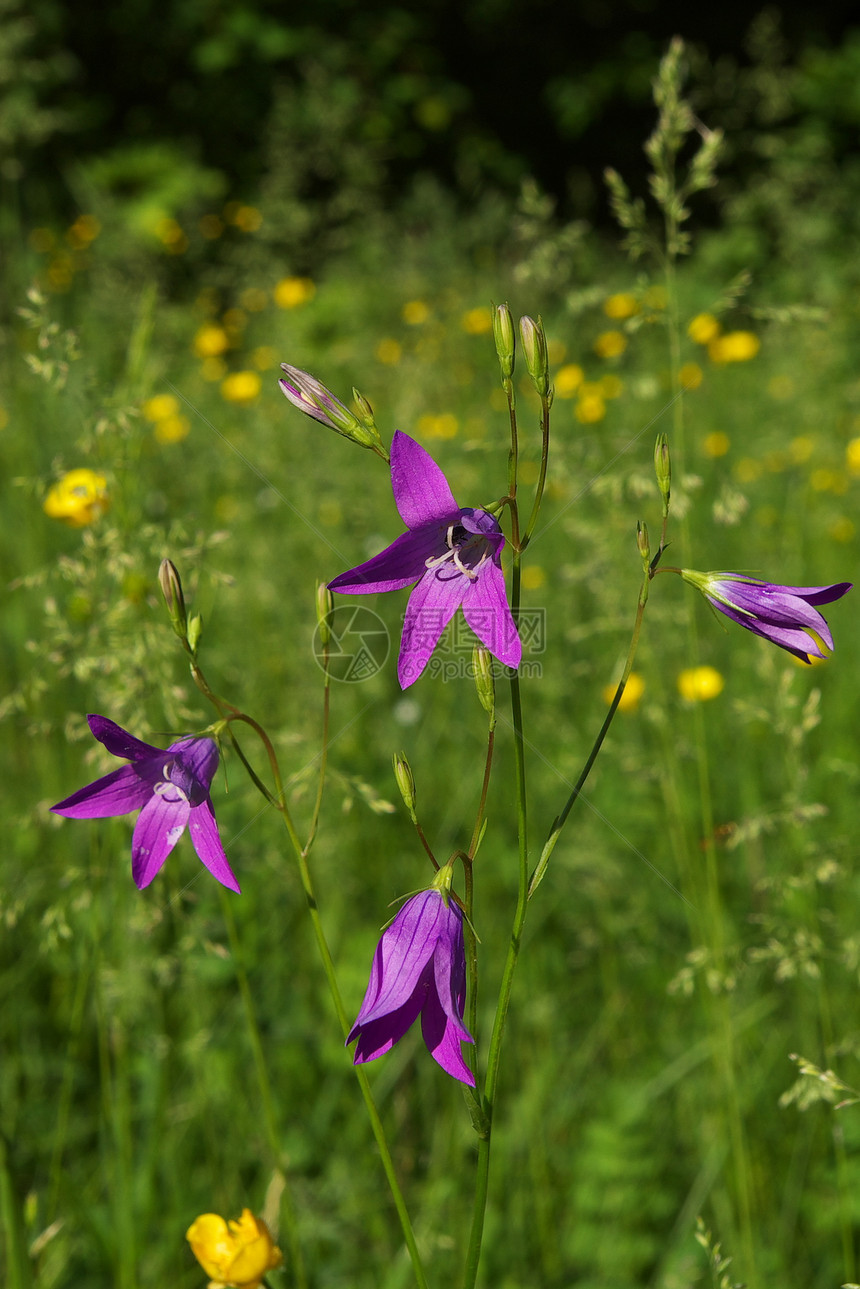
(52, 715, 239, 891)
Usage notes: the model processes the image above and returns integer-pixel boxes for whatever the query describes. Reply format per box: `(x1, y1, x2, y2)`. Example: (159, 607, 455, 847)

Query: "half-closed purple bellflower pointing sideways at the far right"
(681, 568, 851, 663)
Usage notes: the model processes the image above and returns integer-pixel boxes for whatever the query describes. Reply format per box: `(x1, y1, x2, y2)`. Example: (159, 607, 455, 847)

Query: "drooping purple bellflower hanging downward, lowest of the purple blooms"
(347, 887, 474, 1088)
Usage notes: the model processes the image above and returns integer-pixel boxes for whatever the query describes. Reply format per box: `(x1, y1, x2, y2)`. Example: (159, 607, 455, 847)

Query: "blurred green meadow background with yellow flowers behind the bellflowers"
(0, 0, 860, 1289)
